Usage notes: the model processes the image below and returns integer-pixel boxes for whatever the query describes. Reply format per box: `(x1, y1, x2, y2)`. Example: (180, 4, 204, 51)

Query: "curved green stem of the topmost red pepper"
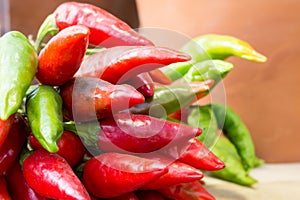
(34, 14, 59, 52)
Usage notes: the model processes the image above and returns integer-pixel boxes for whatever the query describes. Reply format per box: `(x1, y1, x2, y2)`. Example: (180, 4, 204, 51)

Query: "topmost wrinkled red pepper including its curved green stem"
(36, 2, 154, 50)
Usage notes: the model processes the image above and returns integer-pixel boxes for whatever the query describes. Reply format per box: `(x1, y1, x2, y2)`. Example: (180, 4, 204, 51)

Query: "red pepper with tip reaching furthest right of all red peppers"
(164, 138, 225, 171)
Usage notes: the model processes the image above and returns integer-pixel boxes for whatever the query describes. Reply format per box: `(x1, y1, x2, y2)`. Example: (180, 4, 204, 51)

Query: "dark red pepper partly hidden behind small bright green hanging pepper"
(28, 130, 86, 167)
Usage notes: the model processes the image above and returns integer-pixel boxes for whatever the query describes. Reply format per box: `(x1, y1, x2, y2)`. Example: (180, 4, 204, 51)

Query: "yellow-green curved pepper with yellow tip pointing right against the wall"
(160, 34, 267, 81)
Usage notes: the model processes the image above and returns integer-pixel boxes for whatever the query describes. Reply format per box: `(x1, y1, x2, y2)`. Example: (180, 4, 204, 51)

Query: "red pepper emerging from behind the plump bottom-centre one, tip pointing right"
(141, 156, 204, 190)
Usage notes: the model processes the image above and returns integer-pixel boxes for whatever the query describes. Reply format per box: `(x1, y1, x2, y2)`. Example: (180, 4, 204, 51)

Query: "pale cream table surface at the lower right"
(204, 163, 300, 200)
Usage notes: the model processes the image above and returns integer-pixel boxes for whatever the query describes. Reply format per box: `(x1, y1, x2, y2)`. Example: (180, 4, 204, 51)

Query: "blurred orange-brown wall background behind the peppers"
(0, 0, 300, 162)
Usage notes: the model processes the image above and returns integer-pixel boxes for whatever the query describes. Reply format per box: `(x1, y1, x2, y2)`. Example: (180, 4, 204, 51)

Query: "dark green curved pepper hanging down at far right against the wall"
(212, 104, 263, 171)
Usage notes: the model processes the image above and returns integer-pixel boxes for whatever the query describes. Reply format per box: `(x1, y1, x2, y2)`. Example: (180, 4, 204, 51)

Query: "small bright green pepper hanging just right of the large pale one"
(26, 85, 64, 152)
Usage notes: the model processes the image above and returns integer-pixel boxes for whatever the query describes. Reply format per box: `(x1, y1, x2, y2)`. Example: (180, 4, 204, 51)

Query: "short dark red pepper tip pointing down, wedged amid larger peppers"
(125, 72, 154, 97)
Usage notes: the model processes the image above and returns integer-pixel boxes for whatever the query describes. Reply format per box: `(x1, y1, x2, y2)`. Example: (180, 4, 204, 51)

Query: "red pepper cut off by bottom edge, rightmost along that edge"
(159, 181, 215, 200)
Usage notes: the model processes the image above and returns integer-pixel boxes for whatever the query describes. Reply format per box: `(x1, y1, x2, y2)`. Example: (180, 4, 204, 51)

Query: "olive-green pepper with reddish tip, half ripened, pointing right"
(129, 80, 213, 117)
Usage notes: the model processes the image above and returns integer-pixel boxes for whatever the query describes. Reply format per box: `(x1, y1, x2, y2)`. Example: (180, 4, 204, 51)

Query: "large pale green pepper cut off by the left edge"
(0, 31, 38, 120)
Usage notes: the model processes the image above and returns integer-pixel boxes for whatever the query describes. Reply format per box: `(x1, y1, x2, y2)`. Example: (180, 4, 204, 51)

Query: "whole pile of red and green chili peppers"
(0, 2, 266, 200)
